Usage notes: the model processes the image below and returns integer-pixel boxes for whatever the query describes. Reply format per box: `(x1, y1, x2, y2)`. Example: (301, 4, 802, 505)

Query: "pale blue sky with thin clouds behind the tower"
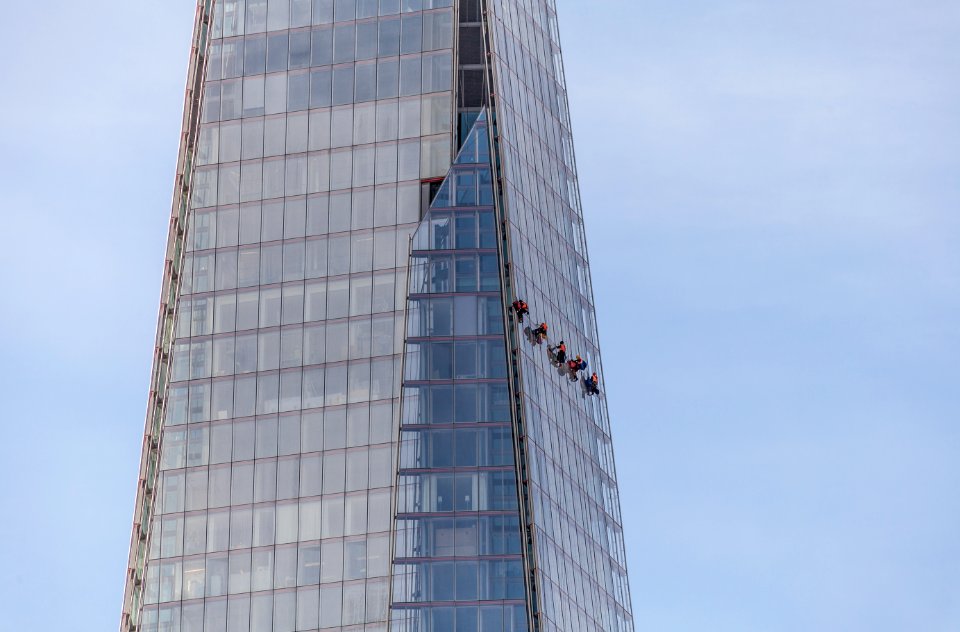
(0, 0, 960, 632)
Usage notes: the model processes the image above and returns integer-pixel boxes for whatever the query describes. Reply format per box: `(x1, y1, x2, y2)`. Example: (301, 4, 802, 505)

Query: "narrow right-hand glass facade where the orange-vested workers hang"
(487, 0, 633, 632)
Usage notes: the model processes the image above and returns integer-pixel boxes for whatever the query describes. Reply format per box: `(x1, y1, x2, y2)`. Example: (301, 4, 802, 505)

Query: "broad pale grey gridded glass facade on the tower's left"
(141, 0, 453, 632)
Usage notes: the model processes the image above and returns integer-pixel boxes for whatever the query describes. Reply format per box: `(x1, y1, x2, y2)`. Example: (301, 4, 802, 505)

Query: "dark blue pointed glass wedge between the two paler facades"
(391, 114, 527, 632)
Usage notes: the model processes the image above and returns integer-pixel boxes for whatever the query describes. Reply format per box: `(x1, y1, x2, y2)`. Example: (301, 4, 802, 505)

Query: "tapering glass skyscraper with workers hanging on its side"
(121, 0, 633, 632)
